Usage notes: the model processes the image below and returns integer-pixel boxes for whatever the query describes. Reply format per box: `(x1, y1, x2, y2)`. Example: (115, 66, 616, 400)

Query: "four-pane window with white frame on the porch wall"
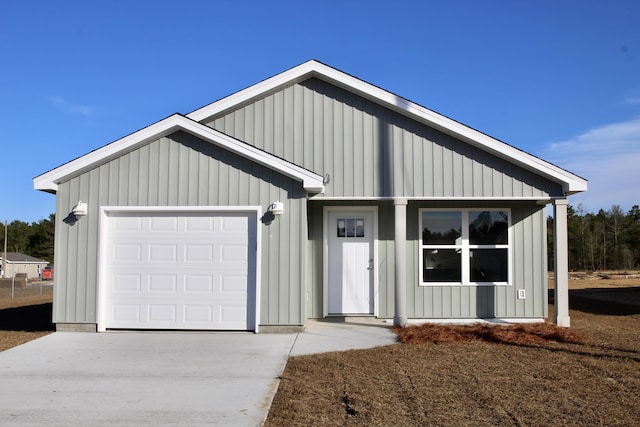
(420, 209, 510, 285)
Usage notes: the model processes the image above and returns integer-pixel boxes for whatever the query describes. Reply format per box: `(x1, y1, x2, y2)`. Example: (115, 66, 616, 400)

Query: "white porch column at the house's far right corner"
(553, 199, 571, 328)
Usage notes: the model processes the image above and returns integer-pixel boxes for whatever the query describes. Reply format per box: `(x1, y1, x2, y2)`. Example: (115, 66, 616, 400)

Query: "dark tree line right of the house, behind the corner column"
(547, 204, 640, 271)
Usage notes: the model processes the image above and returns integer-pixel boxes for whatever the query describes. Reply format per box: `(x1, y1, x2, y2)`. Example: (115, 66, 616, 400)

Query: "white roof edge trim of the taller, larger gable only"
(187, 60, 587, 195)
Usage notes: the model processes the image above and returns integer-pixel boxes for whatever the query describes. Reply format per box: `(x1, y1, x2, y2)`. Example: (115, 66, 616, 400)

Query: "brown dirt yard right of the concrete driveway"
(266, 279, 640, 426)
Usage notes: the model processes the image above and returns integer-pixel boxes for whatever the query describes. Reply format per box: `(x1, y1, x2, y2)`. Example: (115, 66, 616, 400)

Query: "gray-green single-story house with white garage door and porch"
(34, 60, 587, 332)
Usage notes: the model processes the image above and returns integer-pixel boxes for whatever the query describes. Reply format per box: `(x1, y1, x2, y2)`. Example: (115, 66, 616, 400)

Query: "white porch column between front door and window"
(393, 199, 408, 327)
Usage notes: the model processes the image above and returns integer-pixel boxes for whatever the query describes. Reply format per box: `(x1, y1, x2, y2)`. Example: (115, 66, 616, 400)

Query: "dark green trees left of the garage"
(0, 214, 55, 264)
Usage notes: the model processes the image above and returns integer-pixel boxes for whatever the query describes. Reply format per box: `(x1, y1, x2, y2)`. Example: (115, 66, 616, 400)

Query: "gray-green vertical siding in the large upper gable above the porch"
(203, 78, 563, 198)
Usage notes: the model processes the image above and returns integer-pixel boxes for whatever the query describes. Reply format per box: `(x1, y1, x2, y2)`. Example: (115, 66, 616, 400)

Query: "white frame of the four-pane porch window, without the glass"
(418, 207, 513, 286)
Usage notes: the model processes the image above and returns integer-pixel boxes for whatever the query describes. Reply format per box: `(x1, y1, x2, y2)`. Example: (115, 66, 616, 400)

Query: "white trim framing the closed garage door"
(96, 206, 262, 333)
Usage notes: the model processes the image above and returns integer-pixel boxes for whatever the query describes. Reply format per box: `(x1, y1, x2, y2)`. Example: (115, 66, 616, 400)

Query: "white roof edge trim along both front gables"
(33, 60, 587, 195)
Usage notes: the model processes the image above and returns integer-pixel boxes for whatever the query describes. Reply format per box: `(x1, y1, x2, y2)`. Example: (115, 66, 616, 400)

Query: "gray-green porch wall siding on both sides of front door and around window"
(307, 201, 548, 319)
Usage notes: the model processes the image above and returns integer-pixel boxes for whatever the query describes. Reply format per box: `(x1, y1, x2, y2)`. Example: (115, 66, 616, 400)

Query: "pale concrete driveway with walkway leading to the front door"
(0, 321, 395, 426)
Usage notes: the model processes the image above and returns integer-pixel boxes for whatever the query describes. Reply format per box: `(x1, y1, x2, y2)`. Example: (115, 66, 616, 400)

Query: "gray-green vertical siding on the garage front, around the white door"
(53, 132, 307, 325)
